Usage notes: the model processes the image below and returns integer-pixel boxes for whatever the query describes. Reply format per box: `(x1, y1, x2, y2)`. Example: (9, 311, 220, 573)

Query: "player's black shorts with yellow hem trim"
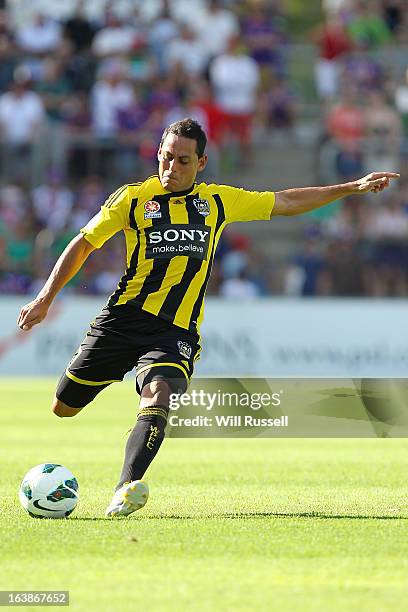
(56, 304, 201, 408)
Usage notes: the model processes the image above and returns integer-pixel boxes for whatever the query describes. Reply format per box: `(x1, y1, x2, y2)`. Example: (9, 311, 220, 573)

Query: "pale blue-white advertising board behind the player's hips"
(0, 298, 408, 378)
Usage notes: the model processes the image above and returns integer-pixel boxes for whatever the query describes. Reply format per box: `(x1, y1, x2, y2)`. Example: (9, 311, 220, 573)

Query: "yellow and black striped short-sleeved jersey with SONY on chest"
(81, 176, 275, 330)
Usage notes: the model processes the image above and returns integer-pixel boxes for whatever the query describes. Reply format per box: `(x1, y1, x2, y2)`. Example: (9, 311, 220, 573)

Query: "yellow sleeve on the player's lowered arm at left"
(80, 185, 130, 249)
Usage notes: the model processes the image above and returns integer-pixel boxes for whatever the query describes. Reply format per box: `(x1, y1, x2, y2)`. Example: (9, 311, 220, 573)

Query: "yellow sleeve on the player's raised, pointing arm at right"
(219, 185, 275, 223)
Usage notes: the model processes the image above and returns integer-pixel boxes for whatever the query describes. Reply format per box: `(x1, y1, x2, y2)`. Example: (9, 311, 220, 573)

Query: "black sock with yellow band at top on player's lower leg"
(116, 406, 169, 490)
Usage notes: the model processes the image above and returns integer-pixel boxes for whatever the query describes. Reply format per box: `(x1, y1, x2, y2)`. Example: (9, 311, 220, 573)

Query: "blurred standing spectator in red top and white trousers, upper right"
(313, 15, 352, 99)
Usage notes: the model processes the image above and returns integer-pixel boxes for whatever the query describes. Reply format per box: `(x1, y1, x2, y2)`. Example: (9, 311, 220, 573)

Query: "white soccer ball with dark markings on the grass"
(19, 463, 79, 518)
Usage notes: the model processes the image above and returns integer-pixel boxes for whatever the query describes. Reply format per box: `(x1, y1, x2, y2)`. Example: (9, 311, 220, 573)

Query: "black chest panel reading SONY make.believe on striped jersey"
(145, 224, 211, 259)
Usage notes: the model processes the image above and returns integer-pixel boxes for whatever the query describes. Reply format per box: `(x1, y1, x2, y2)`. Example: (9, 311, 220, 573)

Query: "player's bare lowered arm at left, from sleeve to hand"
(17, 234, 95, 331)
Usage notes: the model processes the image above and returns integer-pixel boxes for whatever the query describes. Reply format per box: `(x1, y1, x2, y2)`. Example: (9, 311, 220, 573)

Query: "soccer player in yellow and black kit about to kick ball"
(18, 119, 399, 517)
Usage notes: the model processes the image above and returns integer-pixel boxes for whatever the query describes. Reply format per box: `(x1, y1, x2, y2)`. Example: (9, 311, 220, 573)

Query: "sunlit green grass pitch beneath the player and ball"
(0, 379, 408, 612)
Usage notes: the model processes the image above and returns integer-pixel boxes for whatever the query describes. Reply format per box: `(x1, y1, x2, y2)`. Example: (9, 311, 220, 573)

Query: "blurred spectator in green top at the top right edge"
(347, 0, 391, 49)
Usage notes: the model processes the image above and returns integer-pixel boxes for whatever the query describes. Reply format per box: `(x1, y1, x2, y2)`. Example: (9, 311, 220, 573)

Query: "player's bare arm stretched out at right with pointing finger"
(271, 172, 400, 216)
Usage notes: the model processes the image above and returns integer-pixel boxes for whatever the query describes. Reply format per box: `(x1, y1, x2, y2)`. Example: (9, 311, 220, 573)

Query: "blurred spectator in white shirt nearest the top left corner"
(16, 13, 61, 54)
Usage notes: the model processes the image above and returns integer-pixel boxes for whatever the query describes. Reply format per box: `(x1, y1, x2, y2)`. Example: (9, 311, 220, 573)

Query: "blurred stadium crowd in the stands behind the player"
(0, 0, 408, 298)
